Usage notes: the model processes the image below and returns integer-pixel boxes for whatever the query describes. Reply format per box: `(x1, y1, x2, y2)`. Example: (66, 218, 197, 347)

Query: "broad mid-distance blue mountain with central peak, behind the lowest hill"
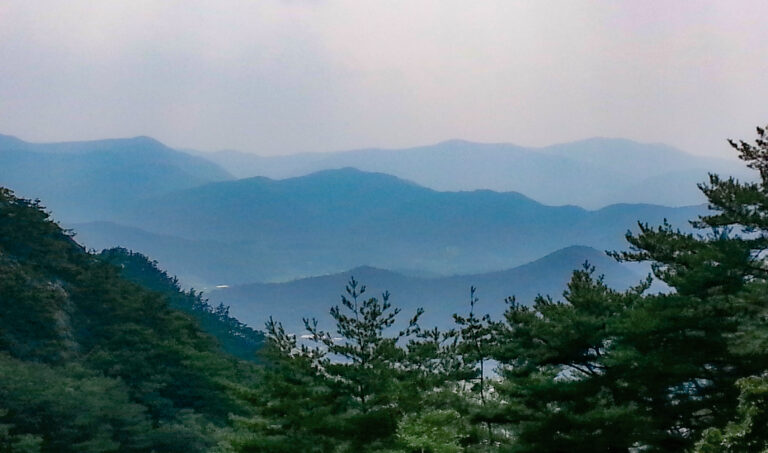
(75, 169, 704, 285)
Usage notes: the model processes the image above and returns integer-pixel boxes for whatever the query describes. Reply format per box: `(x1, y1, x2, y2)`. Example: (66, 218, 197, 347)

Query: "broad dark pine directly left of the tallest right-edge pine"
(495, 267, 648, 452)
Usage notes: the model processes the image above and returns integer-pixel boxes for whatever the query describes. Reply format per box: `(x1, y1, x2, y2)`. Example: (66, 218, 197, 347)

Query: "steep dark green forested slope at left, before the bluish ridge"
(0, 188, 255, 452)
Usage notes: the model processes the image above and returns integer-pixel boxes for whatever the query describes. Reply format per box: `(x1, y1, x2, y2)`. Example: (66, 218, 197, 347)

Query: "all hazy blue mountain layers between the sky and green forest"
(0, 131, 712, 331)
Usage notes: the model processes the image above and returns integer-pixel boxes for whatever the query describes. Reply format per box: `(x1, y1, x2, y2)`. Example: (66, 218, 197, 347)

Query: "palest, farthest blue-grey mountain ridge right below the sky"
(199, 138, 749, 208)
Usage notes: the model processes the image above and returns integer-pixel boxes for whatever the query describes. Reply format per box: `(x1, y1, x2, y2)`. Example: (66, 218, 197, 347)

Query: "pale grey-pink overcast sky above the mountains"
(0, 0, 768, 157)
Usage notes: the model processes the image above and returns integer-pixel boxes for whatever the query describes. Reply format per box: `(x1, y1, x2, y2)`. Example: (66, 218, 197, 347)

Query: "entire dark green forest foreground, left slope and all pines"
(0, 128, 768, 453)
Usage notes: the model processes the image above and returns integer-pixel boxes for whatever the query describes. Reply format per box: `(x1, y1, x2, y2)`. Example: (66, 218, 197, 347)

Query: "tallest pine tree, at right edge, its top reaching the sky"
(619, 128, 768, 447)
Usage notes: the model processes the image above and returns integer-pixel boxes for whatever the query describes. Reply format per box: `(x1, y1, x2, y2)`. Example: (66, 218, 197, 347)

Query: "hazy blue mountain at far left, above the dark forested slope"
(0, 135, 232, 221)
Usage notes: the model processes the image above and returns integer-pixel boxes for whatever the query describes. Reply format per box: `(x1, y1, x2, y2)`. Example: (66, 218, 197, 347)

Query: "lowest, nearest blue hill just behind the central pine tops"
(208, 246, 643, 332)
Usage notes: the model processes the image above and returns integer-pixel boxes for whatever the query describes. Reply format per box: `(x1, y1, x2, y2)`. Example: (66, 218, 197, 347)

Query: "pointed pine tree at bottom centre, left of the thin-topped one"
(305, 277, 421, 451)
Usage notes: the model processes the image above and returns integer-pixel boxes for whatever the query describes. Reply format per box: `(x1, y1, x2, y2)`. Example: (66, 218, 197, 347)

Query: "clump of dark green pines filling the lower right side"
(486, 128, 768, 452)
